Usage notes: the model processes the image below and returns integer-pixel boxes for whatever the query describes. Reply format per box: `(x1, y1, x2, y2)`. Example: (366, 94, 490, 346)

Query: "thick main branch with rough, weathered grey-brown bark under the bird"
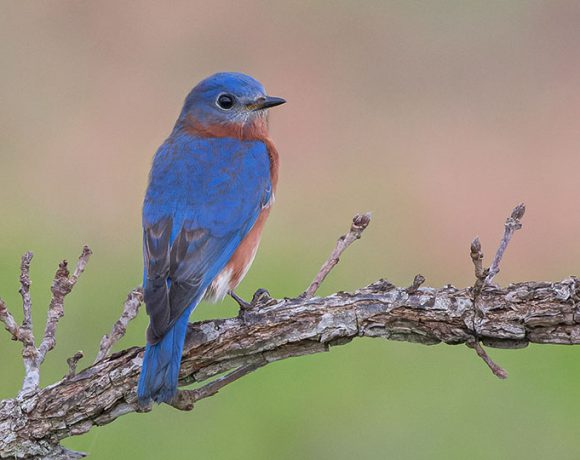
(0, 278, 580, 458)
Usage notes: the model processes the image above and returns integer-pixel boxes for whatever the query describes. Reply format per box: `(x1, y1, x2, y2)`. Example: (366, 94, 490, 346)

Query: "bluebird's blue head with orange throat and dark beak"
(177, 72, 286, 139)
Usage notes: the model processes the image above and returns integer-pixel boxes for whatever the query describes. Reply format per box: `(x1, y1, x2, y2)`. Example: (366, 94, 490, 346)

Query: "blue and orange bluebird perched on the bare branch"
(137, 72, 286, 405)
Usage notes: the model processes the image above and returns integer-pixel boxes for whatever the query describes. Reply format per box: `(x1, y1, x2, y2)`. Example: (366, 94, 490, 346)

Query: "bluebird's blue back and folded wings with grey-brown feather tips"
(143, 134, 271, 343)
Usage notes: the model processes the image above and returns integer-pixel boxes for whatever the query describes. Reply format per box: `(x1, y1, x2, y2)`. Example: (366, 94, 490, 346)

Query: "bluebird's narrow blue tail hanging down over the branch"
(137, 307, 192, 405)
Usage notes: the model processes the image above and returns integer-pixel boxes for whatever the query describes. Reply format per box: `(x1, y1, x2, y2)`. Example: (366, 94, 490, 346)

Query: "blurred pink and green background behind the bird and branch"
(0, 0, 580, 460)
